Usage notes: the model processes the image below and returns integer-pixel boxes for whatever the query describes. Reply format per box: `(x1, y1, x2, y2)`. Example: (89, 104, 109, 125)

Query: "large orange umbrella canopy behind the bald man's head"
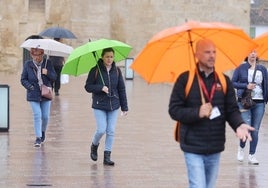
(131, 21, 257, 83)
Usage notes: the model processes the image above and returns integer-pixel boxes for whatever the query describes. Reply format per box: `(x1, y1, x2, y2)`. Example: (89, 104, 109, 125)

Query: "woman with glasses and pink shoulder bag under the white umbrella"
(20, 48, 57, 147)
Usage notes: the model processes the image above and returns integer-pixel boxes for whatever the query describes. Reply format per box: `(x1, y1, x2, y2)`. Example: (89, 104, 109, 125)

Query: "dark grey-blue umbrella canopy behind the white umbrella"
(39, 27, 76, 39)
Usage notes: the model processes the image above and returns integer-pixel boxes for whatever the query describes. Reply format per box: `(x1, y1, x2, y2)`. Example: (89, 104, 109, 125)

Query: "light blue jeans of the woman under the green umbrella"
(92, 109, 118, 151)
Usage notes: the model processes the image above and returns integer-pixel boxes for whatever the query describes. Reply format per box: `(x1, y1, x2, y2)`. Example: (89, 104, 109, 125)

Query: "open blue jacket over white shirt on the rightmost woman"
(232, 62, 268, 103)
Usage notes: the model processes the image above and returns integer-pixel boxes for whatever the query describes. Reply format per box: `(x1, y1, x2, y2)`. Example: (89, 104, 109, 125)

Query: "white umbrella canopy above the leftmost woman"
(20, 39, 73, 57)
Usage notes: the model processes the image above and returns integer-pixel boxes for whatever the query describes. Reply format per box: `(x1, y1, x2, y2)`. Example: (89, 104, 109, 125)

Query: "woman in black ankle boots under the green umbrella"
(85, 48, 128, 165)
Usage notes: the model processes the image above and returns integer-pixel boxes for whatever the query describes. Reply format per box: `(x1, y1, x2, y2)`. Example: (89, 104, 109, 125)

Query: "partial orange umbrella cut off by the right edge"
(254, 32, 268, 60)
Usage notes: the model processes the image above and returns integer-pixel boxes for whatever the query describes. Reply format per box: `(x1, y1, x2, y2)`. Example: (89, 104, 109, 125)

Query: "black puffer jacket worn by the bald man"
(169, 69, 244, 154)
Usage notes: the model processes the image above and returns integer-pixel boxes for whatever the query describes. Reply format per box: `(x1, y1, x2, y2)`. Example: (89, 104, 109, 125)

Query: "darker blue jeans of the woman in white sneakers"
(238, 102, 265, 154)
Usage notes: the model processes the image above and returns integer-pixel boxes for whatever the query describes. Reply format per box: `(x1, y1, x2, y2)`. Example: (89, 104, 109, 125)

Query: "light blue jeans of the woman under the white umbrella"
(29, 101, 51, 138)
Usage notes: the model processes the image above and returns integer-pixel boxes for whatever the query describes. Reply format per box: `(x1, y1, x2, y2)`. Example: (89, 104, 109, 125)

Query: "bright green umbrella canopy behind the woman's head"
(61, 39, 132, 76)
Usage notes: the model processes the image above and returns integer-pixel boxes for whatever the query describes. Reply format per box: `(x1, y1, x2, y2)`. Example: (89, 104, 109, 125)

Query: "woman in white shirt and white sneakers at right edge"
(232, 50, 268, 165)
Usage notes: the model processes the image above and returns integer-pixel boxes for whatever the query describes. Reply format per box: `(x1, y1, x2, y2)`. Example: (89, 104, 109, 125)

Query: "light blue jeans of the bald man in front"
(184, 152, 220, 188)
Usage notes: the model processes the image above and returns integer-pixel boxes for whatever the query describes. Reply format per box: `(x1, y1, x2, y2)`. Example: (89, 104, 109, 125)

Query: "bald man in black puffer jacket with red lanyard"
(169, 40, 254, 188)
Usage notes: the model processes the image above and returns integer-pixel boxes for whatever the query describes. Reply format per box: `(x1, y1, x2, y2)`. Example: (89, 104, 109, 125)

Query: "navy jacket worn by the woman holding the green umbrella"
(85, 59, 128, 111)
